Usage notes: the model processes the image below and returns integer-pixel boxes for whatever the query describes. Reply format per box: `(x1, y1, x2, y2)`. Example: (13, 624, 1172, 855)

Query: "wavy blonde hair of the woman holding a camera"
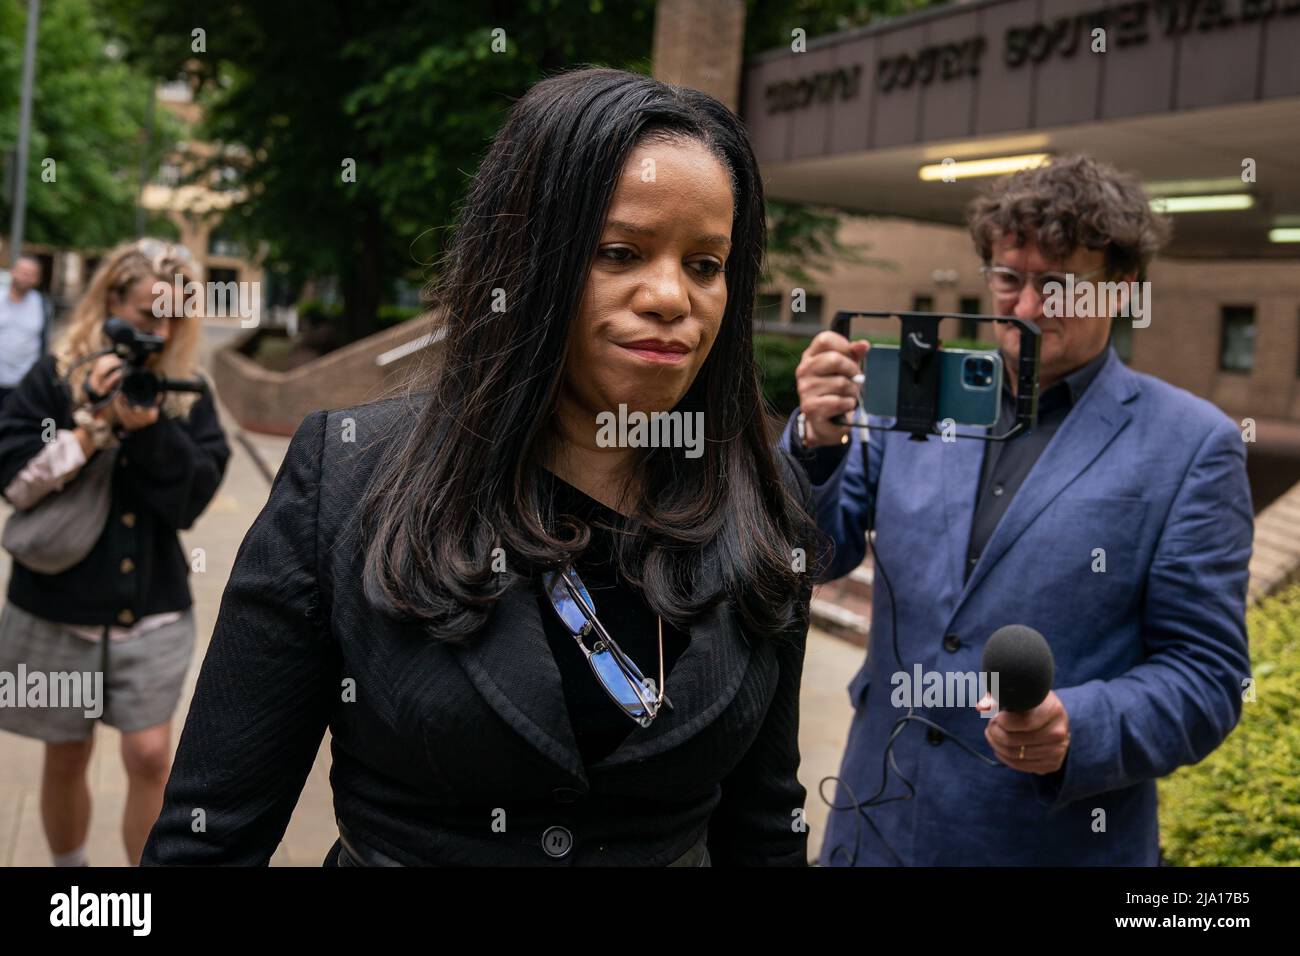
(52, 238, 203, 418)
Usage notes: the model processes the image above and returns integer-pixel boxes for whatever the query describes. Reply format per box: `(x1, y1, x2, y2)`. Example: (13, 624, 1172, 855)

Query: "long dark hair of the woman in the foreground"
(360, 69, 822, 640)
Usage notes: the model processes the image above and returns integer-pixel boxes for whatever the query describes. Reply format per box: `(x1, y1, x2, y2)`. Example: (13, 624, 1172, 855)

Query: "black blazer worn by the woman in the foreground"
(143, 399, 811, 866)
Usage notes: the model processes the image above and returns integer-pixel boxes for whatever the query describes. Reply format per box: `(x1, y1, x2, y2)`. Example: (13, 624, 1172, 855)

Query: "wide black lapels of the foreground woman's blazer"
(454, 544, 751, 783)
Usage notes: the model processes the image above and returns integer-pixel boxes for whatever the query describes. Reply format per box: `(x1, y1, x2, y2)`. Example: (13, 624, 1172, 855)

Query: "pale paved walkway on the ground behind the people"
(0, 329, 862, 866)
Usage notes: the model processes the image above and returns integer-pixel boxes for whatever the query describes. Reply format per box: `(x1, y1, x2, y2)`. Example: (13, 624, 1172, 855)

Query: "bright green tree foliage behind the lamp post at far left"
(0, 0, 178, 248)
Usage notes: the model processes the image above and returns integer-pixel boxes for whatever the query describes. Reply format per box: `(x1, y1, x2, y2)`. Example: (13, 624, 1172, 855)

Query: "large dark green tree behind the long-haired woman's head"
(101, 0, 935, 341)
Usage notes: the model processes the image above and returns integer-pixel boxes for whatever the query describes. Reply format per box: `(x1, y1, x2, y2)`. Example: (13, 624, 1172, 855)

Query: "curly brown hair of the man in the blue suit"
(967, 155, 1170, 280)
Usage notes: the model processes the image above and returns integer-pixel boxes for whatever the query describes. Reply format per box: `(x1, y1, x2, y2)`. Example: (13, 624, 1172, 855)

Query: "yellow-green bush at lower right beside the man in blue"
(1160, 585, 1300, 866)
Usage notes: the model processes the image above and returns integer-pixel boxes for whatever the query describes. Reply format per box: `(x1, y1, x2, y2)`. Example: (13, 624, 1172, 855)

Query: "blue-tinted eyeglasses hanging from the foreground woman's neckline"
(542, 566, 672, 727)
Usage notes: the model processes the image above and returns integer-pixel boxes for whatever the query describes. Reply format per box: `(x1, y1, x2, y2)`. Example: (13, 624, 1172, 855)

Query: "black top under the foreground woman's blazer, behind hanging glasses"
(537, 471, 690, 763)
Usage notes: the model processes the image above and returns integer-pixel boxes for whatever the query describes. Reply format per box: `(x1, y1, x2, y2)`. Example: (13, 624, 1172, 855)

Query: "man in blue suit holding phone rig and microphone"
(781, 157, 1253, 866)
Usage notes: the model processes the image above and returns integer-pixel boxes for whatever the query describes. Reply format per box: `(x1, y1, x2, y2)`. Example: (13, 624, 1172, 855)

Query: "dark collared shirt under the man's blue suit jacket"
(963, 346, 1110, 578)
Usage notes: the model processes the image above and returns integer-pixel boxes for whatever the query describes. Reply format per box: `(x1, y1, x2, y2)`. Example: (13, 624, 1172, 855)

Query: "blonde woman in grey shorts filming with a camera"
(0, 239, 230, 866)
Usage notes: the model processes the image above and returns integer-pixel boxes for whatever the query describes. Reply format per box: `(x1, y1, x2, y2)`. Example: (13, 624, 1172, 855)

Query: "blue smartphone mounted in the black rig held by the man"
(862, 345, 1002, 425)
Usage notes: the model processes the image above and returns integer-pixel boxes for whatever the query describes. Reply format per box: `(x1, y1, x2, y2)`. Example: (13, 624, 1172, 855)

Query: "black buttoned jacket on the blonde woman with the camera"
(0, 355, 230, 626)
